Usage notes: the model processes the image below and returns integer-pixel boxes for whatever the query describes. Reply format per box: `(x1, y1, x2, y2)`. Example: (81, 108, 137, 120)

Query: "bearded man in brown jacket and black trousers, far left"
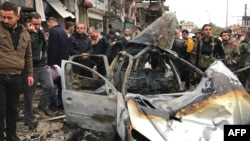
(0, 1, 34, 141)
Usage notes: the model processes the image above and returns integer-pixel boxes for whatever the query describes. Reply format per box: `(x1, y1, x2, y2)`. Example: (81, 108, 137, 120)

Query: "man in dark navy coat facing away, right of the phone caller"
(47, 17, 70, 108)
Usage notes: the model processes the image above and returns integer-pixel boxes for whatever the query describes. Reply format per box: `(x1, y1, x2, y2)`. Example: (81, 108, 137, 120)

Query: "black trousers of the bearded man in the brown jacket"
(0, 74, 21, 141)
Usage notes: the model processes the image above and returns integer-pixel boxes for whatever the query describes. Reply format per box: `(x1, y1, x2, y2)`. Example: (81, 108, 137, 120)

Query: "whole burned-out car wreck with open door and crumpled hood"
(62, 12, 250, 141)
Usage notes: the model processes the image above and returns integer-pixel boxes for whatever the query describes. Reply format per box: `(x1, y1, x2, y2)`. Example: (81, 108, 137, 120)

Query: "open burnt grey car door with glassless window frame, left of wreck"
(62, 61, 117, 132)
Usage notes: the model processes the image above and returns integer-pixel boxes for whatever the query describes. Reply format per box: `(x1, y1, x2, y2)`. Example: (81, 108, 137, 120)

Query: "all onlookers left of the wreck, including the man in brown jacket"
(0, 1, 142, 141)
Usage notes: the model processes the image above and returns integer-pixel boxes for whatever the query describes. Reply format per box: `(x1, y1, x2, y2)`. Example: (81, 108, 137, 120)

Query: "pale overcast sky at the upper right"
(165, 0, 250, 27)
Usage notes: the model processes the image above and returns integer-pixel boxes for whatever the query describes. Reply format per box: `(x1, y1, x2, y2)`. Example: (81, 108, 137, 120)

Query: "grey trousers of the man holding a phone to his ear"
(24, 65, 54, 122)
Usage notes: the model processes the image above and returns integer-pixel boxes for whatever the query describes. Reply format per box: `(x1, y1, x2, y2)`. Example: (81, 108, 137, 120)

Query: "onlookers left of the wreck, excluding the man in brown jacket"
(22, 12, 142, 132)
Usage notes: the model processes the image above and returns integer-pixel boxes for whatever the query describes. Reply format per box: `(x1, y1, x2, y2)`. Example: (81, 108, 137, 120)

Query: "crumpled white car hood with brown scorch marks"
(126, 61, 250, 141)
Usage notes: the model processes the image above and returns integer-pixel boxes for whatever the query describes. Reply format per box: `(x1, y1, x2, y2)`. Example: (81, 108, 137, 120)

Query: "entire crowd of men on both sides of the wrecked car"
(0, 1, 250, 141)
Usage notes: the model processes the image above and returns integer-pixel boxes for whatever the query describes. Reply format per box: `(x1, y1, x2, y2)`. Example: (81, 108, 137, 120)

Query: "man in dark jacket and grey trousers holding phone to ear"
(23, 12, 54, 129)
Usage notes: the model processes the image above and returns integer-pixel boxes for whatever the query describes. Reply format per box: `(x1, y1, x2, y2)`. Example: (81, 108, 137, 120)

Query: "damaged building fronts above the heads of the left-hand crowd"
(0, 0, 168, 33)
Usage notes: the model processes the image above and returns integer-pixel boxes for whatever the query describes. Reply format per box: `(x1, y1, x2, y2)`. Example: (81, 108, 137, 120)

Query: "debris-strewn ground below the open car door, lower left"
(17, 86, 112, 141)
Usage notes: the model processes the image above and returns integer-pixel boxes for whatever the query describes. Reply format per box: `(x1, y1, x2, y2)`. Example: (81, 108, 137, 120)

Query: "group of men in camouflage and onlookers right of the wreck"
(172, 24, 250, 93)
